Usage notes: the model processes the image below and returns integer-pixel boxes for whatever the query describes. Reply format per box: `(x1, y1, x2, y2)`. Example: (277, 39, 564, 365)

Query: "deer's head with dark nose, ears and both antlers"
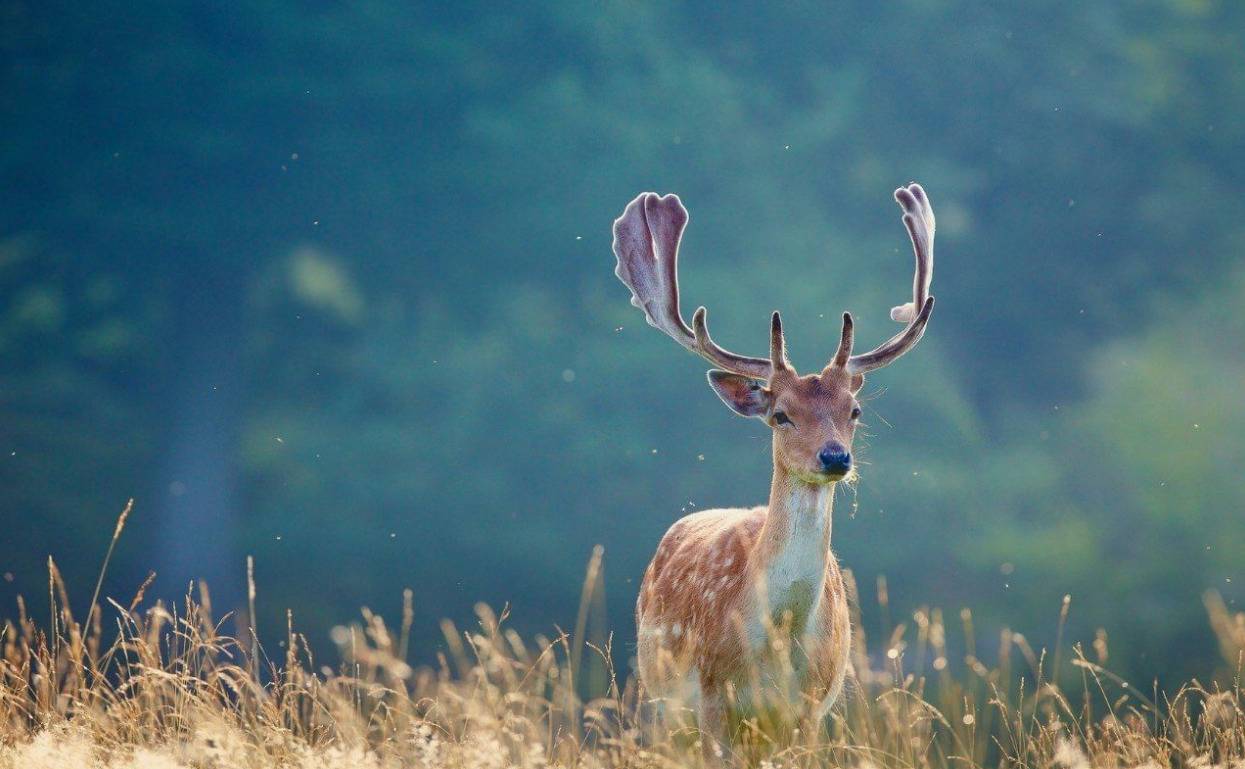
(614, 183, 934, 483)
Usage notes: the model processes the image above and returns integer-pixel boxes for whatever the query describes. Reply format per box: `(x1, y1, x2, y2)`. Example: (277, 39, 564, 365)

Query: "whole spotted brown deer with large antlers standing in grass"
(614, 183, 934, 753)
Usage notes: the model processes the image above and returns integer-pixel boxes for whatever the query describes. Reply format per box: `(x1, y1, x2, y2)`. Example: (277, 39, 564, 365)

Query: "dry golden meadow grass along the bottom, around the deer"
(0, 502, 1245, 769)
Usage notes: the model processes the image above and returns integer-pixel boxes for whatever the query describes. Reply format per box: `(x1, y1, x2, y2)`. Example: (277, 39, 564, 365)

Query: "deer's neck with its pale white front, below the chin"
(756, 463, 834, 623)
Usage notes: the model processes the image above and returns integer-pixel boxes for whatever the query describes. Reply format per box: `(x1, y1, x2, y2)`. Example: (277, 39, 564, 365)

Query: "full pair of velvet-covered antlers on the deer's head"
(614, 183, 934, 380)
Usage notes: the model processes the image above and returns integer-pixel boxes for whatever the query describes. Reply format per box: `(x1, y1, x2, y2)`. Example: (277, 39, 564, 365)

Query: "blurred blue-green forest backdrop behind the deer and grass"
(0, 0, 1245, 679)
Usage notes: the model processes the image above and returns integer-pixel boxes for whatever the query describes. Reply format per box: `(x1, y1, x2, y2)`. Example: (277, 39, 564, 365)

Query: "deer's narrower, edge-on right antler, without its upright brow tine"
(835, 182, 935, 373)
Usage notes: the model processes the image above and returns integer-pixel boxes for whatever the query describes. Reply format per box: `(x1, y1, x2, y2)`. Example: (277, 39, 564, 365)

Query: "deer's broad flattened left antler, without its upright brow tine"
(614, 193, 772, 380)
